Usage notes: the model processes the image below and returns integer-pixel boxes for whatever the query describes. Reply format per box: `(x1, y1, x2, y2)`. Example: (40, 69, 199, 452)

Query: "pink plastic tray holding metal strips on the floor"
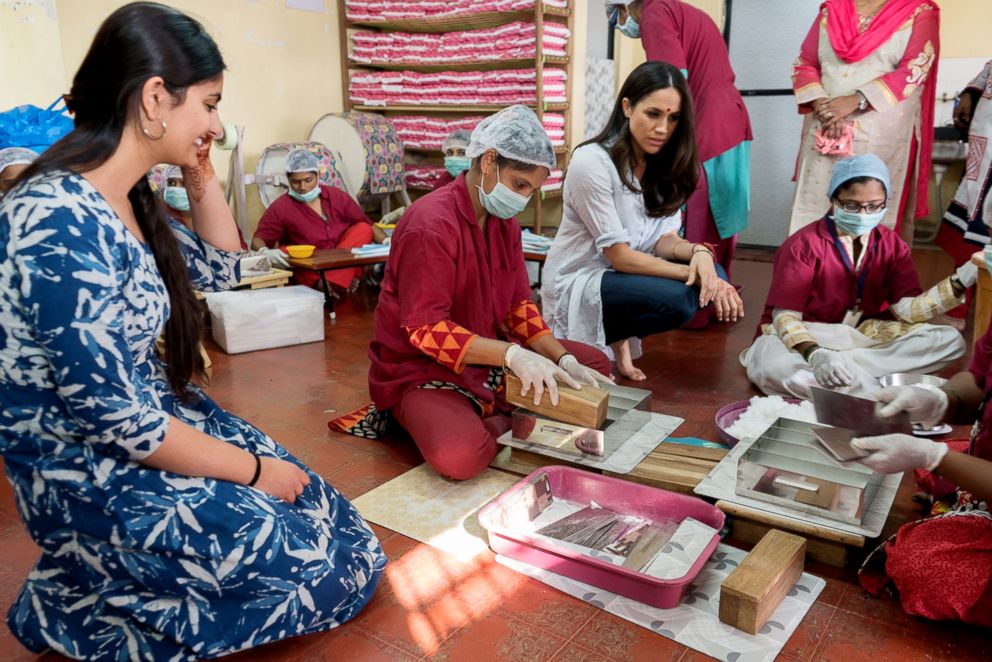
(479, 466, 723, 609)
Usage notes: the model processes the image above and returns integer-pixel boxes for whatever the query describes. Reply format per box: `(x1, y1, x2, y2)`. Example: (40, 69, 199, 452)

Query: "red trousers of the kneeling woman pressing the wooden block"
(390, 340, 611, 480)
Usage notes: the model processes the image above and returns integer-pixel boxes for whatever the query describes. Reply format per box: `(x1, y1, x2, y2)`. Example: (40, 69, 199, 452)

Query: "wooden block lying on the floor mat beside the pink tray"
(720, 529, 806, 634)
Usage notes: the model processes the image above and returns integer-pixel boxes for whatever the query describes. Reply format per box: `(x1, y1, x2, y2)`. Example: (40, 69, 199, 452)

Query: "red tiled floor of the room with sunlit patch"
(0, 251, 992, 662)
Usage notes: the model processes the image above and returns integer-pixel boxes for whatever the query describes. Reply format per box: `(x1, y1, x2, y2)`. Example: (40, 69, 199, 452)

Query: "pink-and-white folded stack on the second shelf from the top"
(351, 21, 568, 65)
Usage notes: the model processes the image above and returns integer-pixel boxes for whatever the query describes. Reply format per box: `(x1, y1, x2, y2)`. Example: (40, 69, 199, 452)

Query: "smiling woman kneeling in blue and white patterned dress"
(0, 3, 385, 660)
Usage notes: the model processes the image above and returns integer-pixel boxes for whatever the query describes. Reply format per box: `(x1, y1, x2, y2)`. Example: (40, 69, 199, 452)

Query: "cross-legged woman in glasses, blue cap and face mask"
(741, 154, 978, 399)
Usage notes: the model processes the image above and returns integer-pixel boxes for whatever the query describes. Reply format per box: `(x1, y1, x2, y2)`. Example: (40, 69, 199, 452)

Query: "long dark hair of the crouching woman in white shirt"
(580, 62, 699, 218)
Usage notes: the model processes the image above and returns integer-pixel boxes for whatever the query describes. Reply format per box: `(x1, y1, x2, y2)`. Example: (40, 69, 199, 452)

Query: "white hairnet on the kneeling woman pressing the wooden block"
(465, 105, 558, 170)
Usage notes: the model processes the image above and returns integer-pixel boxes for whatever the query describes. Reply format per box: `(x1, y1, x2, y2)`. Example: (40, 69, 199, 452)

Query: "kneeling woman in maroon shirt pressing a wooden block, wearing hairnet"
(331, 106, 610, 480)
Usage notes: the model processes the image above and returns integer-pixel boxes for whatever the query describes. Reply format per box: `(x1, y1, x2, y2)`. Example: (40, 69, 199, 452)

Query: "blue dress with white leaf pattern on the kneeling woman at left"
(0, 172, 386, 660)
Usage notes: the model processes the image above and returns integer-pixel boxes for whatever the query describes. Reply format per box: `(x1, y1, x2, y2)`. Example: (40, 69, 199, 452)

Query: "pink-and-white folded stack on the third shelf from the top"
(348, 68, 566, 107)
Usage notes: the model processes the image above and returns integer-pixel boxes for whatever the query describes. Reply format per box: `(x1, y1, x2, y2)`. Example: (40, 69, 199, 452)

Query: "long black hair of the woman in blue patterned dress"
(21, 2, 225, 397)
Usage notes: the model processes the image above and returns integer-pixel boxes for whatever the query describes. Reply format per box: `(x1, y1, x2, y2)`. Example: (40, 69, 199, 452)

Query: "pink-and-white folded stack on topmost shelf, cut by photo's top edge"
(345, 0, 568, 23)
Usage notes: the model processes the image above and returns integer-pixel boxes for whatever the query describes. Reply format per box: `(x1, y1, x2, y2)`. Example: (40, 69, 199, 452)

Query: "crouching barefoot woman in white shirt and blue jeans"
(541, 62, 744, 380)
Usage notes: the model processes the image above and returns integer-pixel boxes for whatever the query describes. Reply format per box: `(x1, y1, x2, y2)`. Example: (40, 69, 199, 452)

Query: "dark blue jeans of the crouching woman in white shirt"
(599, 264, 727, 344)
